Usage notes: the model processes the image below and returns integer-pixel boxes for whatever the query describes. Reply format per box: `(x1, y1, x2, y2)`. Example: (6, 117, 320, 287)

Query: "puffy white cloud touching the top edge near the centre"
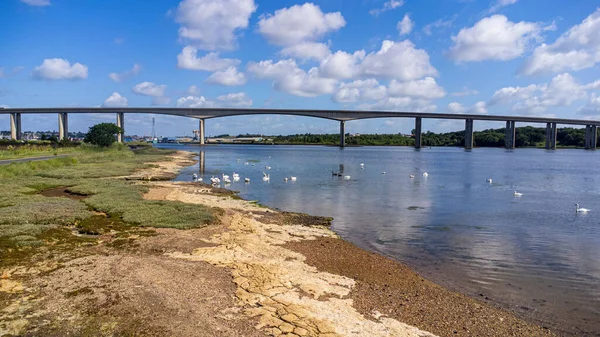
(258, 2, 346, 46)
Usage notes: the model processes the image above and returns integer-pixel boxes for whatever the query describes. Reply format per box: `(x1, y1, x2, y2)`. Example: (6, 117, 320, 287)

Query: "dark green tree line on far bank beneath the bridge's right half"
(269, 126, 596, 147)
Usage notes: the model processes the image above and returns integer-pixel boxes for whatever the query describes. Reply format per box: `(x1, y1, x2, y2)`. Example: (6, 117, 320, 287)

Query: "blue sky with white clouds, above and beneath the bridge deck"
(0, 0, 600, 136)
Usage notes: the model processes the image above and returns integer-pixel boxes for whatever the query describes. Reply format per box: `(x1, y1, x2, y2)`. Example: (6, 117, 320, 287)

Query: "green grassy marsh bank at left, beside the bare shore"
(0, 146, 215, 267)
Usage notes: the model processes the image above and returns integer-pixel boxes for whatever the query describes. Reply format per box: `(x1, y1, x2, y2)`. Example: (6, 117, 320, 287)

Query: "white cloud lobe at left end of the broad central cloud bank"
(248, 59, 337, 97)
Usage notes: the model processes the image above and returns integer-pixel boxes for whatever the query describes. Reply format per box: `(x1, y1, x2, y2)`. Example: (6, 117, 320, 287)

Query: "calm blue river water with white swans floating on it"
(159, 145, 600, 335)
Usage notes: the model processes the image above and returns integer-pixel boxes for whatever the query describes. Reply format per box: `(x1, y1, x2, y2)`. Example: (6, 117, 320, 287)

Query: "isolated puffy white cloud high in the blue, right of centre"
(448, 15, 542, 62)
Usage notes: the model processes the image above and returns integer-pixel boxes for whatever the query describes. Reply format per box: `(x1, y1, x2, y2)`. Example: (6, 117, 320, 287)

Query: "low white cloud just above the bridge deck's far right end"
(489, 73, 594, 114)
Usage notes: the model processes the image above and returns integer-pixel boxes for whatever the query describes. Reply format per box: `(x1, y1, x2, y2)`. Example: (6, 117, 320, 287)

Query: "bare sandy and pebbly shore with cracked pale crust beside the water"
(0, 152, 552, 336)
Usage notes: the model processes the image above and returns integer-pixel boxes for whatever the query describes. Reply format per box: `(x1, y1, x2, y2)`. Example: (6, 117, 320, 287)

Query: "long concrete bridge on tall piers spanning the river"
(0, 107, 600, 149)
